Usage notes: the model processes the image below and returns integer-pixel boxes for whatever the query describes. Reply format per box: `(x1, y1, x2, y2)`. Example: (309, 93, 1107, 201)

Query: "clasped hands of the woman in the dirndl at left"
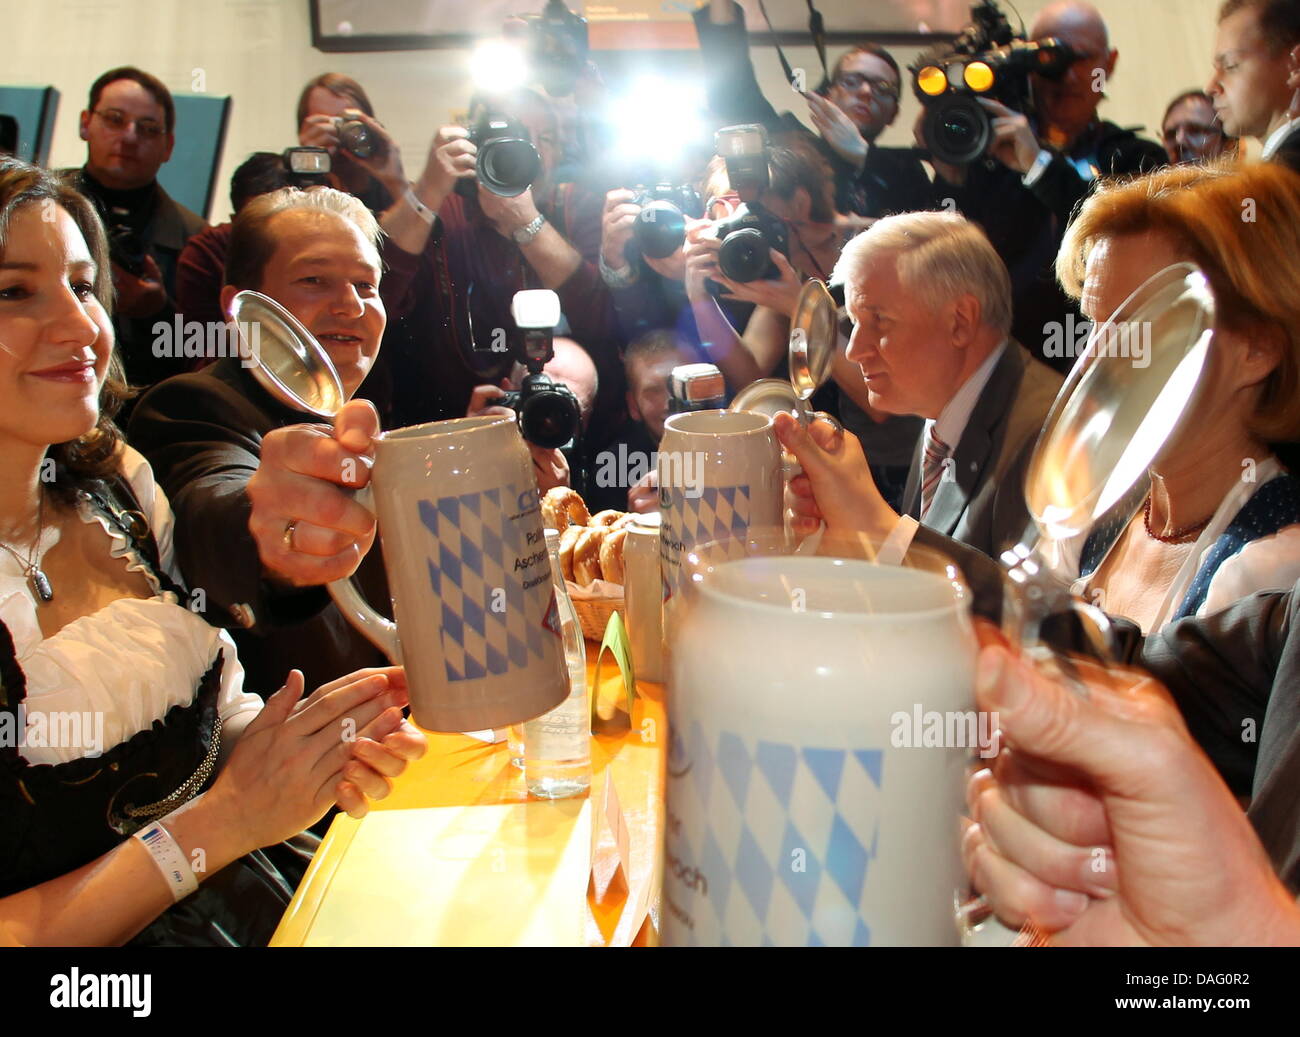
(204, 668, 407, 852)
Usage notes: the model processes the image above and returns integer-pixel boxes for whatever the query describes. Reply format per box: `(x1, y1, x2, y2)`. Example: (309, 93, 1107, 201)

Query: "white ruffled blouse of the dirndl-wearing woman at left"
(0, 448, 263, 764)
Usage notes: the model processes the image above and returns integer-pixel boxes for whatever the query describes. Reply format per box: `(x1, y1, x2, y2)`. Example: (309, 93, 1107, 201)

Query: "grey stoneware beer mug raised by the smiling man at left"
(329, 416, 569, 732)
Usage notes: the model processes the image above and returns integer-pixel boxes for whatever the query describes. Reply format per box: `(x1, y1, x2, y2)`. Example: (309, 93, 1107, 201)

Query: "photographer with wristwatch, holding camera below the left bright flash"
(377, 90, 621, 441)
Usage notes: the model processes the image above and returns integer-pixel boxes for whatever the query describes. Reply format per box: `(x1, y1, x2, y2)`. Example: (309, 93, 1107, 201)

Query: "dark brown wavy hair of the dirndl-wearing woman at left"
(0, 157, 130, 503)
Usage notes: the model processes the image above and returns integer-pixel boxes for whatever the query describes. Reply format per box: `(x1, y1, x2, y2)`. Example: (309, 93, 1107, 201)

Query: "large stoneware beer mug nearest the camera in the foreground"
(663, 537, 977, 946)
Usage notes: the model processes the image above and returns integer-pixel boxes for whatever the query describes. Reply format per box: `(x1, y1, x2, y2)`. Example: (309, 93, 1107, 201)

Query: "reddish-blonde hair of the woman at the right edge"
(1057, 162, 1300, 443)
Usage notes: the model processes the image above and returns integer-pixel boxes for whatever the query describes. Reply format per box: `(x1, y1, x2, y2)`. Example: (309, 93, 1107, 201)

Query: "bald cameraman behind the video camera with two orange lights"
(918, 0, 1166, 370)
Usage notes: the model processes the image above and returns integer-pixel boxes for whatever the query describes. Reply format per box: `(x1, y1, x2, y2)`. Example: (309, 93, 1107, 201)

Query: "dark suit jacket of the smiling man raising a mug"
(129, 359, 389, 694)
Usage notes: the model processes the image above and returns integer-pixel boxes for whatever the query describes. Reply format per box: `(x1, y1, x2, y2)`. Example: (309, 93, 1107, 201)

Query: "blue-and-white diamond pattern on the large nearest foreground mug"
(666, 723, 884, 946)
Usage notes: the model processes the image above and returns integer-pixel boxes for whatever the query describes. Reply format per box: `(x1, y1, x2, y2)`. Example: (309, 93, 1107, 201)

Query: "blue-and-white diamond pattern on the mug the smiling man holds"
(420, 486, 554, 681)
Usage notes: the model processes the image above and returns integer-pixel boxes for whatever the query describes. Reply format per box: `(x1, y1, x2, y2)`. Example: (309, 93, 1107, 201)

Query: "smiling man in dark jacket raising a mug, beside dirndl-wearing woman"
(130, 188, 387, 693)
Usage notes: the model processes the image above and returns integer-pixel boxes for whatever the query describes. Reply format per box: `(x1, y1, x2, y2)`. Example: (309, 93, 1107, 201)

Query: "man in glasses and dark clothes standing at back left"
(68, 66, 208, 397)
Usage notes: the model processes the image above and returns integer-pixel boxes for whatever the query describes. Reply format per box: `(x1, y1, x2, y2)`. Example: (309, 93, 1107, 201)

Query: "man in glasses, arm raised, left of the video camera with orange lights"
(694, 0, 935, 217)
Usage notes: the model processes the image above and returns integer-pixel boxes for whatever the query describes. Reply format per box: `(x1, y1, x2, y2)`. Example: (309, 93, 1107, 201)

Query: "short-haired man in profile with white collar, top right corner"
(1205, 0, 1300, 172)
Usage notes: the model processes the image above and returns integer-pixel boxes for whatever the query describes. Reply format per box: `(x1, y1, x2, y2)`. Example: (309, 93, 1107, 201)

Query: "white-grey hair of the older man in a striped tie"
(831, 212, 1011, 335)
